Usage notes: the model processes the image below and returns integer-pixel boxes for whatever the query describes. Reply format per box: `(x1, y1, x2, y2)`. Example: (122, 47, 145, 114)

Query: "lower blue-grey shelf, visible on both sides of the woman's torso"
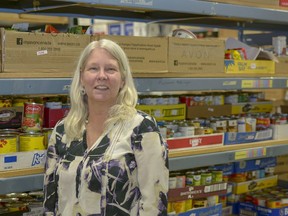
(0, 140, 288, 194)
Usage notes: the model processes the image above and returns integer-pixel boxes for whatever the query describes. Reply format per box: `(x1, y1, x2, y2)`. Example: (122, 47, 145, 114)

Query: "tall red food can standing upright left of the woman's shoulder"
(22, 102, 44, 132)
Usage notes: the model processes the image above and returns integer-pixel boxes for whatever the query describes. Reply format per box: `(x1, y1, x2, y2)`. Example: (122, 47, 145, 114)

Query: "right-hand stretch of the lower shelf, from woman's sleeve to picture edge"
(169, 140, 288, 171)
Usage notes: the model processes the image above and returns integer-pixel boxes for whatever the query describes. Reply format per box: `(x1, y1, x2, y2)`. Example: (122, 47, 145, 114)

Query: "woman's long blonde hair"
(64, 39, 138, 141)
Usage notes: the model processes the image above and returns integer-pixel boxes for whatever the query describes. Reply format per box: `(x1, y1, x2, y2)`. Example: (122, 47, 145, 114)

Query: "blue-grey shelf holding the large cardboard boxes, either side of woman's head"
(0, 77, 288, 95)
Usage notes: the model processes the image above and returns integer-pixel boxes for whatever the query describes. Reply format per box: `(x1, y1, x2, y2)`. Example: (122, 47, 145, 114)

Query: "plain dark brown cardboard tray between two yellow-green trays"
(186, 104, 232, 119)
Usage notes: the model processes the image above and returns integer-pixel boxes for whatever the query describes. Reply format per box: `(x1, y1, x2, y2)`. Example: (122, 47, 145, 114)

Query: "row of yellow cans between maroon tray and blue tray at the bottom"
(167, 195, 222, 215)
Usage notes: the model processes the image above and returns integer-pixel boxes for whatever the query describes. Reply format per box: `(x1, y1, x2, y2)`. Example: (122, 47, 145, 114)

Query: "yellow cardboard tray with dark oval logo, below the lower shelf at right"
(233, 175, 278, 194)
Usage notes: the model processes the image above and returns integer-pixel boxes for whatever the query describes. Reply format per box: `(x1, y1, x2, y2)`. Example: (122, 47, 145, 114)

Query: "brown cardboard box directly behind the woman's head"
(91, 35, 168, 73)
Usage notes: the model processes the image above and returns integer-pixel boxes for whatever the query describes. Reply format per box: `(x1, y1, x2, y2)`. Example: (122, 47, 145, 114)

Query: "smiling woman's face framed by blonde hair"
(81, 48, 124, 105)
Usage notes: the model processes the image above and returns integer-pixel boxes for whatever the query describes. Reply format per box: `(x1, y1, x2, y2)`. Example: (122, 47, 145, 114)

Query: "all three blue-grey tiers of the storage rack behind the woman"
(0, 0, 288, 194)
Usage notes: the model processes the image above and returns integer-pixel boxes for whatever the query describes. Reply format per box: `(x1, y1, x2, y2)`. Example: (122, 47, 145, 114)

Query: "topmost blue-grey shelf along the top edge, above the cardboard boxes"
(0, 0, 288, 31)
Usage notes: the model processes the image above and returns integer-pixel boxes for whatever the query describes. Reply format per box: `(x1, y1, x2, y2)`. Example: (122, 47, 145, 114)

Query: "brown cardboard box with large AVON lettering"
(168, 37, 225, 76)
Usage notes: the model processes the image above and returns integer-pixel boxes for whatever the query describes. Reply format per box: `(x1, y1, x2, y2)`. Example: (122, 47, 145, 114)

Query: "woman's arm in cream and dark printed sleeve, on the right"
(134, 116, 169, 216)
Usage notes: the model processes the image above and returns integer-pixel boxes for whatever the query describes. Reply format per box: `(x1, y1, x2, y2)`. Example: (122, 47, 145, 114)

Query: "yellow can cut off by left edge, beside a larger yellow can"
(0, 134, 18, 154)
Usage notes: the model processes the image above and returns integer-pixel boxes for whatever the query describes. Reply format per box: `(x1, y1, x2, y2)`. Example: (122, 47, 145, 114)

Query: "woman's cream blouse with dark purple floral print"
(44, 111, 169, 216)
